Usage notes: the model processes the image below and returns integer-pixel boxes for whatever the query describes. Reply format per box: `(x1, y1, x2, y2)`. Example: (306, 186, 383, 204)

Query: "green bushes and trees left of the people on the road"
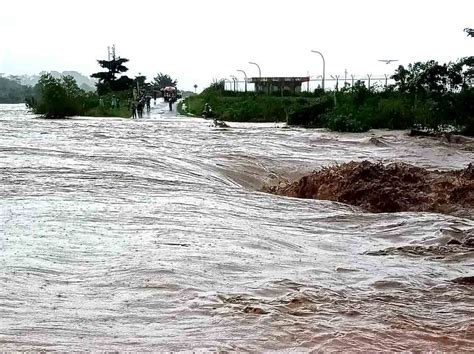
(26, 54, 181, 118)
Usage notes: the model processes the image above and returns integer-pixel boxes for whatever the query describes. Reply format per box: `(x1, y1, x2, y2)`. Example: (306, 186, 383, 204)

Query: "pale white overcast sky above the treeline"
(0, 0, 474, 90)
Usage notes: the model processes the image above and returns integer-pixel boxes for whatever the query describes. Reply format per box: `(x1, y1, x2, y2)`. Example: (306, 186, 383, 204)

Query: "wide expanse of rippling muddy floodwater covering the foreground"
(0, 104, 474, 351)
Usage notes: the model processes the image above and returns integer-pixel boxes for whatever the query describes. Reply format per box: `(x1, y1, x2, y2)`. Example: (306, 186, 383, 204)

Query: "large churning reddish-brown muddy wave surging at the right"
(262, 161, 474, 218)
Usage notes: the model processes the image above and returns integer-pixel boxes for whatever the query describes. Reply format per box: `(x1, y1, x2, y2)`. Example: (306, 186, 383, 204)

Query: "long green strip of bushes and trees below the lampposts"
(180, 57, 474, 135)
